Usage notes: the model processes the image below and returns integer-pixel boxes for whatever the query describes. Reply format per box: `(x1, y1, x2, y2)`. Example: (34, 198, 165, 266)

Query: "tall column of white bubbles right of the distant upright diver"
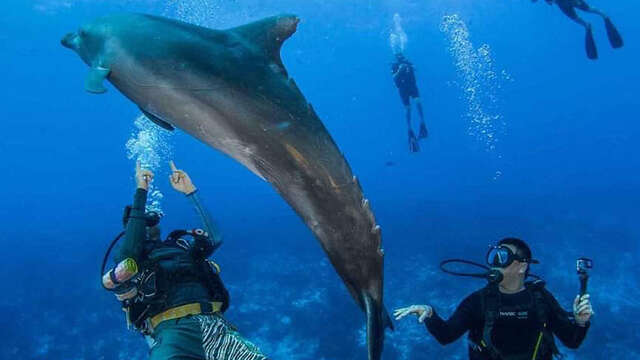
(440, 14, 513, 155)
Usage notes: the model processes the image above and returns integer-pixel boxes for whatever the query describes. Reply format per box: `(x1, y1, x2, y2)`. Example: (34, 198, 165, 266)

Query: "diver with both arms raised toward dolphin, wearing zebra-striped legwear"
(101, 162, 267, 360)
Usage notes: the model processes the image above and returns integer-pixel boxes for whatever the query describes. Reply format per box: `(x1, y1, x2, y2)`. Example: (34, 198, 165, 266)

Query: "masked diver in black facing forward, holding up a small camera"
(394, 238, 593, 360)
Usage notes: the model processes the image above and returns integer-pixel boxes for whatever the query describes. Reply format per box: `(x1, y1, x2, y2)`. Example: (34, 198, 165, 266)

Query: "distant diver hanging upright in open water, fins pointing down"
(391, 53, 429, 152)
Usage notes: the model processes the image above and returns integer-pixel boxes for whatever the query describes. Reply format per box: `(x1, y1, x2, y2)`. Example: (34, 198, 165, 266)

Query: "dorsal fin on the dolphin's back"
(228, 15, 300, 74)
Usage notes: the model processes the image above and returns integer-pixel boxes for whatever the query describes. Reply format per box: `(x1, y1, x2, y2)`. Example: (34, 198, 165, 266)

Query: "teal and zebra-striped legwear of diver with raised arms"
(148, 314, 268, 360)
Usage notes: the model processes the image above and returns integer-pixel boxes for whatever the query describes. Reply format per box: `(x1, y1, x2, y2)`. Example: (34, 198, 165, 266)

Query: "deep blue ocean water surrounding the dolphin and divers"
(0, 0, 640, 360)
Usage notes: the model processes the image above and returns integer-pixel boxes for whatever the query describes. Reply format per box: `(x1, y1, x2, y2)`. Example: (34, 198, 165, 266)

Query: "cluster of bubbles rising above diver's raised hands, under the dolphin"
(126, 115, 173, 213)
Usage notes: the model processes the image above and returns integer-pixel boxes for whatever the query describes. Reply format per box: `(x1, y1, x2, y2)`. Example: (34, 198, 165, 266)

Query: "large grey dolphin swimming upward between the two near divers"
(61, 13, 392, 360)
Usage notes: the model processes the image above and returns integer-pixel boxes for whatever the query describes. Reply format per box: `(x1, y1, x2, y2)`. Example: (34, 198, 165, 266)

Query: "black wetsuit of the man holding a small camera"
(426, 288, 589, 360)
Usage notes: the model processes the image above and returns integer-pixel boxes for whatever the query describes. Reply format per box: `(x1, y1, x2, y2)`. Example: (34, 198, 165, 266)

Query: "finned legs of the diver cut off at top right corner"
(531, 0, 624, 60)
